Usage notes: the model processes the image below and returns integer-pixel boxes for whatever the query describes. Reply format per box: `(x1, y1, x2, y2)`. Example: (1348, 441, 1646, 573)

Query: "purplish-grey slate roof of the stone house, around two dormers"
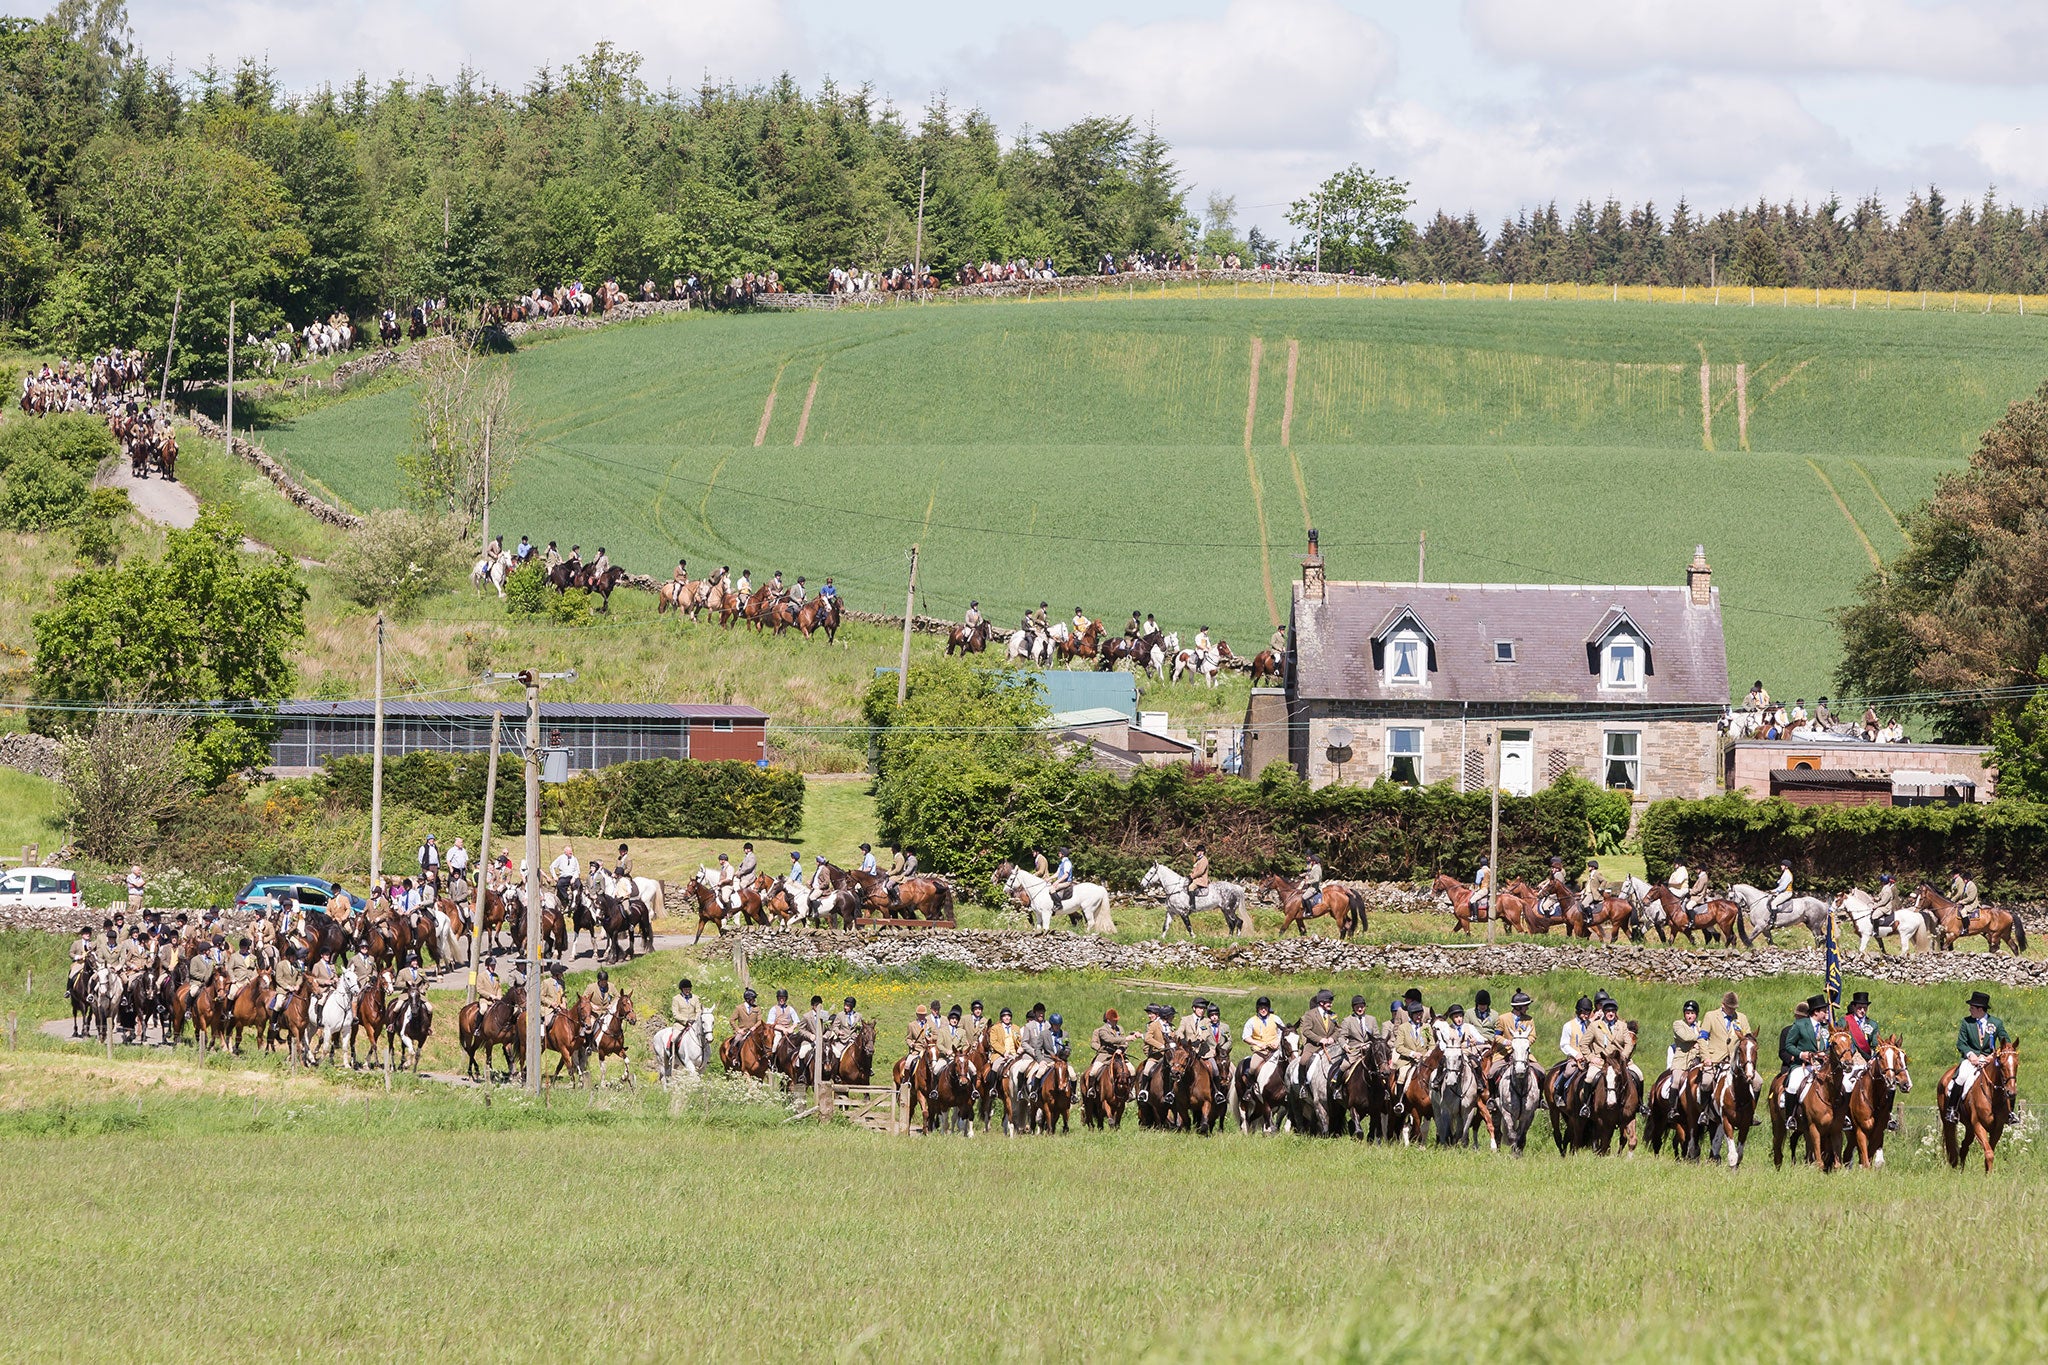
(1294, 581, 1729, 708)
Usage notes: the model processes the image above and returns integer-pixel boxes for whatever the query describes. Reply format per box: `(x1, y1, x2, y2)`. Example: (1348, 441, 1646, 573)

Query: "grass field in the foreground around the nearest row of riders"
(0, 935, 2048, 1361)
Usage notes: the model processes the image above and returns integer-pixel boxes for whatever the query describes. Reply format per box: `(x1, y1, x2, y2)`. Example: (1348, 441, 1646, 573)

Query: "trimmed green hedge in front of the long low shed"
(326, 751, 803, 839)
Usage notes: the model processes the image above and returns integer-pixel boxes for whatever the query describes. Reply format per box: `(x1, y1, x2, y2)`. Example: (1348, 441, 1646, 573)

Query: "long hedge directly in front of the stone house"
(877, 759, 1628, 890)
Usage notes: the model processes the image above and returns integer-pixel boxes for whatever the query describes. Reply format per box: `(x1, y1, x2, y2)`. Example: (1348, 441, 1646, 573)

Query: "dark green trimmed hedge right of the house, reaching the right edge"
(1642, 792, 2048, 900)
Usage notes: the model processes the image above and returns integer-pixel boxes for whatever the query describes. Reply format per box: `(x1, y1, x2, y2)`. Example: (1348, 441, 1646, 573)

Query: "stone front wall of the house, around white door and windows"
(1307, 702, 1720, 802)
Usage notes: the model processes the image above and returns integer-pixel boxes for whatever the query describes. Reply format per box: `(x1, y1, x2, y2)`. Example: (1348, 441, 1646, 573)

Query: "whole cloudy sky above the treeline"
(131, 0, 2048, 231)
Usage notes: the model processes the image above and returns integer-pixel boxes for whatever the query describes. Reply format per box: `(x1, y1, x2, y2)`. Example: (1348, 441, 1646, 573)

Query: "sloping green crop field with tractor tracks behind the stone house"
(266, 297, 2048, 696)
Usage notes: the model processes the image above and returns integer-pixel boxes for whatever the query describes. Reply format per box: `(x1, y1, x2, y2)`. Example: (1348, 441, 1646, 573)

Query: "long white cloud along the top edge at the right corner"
(1464, 0, 2048, 84)
